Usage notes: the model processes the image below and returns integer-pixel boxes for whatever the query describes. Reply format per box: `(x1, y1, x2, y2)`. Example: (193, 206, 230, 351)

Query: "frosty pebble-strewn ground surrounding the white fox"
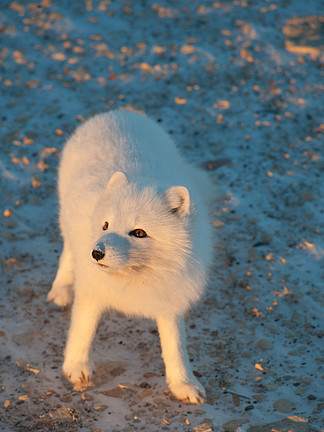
(0, 0, 324, 432)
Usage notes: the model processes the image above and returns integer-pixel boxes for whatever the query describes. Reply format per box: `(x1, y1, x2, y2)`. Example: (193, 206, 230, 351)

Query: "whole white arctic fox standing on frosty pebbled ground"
(48, 111, 212, 404)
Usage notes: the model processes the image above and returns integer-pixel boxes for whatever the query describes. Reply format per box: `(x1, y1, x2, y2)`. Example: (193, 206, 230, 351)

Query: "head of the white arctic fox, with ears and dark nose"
(89, 171, 191, 274)
